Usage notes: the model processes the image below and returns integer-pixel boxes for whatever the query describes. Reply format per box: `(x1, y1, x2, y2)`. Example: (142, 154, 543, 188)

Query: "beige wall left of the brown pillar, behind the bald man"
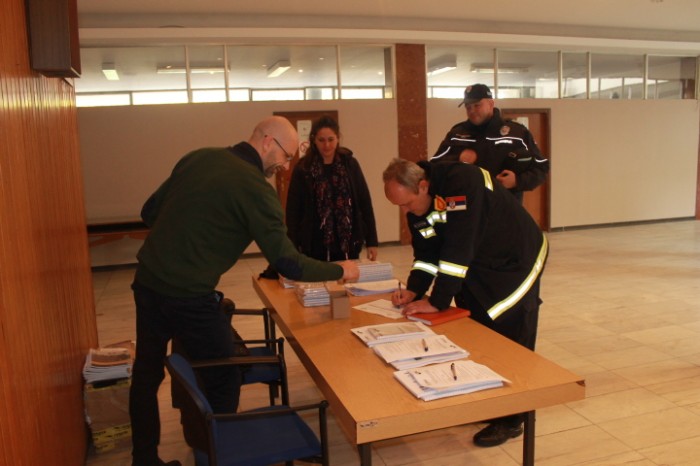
(78, 100, 399, 246)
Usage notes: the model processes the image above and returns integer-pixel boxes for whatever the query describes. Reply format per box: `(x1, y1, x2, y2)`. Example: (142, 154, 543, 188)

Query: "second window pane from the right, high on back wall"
(591, 53, 644, 99)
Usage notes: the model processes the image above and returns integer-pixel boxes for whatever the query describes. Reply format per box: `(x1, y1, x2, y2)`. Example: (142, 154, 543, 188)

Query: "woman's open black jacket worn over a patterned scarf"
(286, 147, 378, 260)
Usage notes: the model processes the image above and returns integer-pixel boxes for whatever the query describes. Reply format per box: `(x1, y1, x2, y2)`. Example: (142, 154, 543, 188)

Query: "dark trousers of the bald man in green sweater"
(129, 282, 241, 466)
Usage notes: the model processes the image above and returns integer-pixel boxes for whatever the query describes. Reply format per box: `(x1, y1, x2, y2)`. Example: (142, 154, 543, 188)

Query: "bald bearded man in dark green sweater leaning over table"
(129, 116, 359, 466)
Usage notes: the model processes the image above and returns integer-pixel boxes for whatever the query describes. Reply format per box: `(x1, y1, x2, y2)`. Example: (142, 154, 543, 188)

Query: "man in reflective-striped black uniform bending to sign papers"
(383, 159, 548, 447)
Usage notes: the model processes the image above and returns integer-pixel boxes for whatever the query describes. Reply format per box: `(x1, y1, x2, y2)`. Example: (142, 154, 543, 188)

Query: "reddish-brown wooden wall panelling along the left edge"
(0, 0, 97, 466)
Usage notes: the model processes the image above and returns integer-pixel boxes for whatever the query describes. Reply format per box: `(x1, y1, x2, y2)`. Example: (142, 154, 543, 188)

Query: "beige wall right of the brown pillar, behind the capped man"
(428, 99, 700, 228)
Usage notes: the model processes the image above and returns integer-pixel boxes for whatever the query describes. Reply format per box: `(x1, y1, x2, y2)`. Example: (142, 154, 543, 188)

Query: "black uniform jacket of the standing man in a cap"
(430, 108, 549, 199)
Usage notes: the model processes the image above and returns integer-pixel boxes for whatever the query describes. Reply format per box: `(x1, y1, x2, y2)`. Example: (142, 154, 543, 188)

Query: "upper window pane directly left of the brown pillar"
(340, 46, 393, 99)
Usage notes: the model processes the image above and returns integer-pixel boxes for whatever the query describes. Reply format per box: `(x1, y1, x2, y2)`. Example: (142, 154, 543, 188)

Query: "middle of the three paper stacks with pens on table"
(373, 335, 469, 369)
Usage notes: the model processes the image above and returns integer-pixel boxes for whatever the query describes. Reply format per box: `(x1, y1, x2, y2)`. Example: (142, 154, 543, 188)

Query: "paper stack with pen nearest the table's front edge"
(394, 361, 510, 401)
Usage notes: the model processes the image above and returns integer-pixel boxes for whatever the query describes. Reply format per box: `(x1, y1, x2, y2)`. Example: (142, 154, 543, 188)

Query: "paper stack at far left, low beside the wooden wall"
(83, 341, 134, 383)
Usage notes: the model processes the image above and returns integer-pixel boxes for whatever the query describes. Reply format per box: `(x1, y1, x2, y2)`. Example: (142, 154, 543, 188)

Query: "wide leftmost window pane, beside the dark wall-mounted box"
(75, 46, 187, 94)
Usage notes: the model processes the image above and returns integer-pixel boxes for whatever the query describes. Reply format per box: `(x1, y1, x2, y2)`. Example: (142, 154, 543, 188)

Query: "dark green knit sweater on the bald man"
(136, 142, 343, 297)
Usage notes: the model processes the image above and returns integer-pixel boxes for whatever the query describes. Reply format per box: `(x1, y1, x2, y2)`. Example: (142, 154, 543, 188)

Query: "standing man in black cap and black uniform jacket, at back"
(431, 84, 549, 202)
